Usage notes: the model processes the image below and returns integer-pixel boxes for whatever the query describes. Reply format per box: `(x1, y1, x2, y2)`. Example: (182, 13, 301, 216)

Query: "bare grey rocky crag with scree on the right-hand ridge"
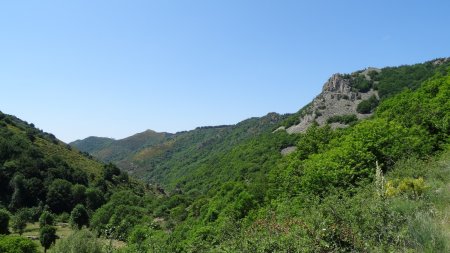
(286, 68, 380, 133)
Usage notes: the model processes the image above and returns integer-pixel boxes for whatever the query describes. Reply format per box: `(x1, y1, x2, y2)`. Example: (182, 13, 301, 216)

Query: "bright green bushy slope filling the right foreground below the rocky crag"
(110, 60, 450, 252)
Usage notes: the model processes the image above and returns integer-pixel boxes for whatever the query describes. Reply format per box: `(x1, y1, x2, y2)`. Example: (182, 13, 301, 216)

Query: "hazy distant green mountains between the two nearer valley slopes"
(70, 113, 286, 189)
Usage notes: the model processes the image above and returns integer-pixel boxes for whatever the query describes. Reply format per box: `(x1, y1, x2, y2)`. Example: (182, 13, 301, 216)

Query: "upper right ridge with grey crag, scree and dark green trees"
(280, 58, 450, 133)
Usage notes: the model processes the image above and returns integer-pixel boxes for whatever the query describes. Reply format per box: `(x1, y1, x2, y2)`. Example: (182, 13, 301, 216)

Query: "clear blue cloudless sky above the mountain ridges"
(0, 0, 450, 142)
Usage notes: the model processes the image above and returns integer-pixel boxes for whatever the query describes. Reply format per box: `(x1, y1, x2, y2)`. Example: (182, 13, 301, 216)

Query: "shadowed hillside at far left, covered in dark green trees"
(0, 112, 147, 213)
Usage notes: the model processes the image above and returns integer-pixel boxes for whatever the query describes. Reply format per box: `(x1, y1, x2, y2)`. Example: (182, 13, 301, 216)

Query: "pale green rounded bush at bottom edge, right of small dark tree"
(50, 229, 105, 253)
